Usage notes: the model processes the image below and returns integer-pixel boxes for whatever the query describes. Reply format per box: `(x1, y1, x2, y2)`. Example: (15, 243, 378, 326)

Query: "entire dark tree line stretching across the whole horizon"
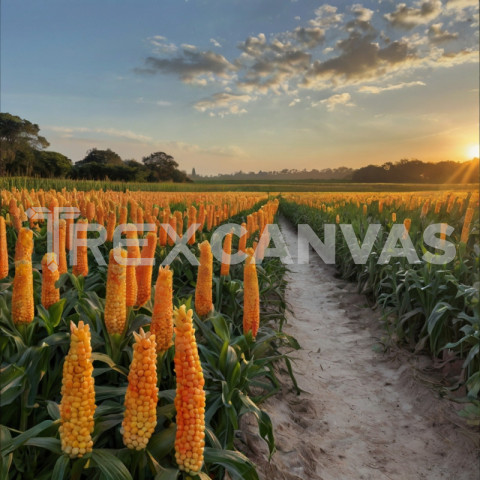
(0, 113, 479, 183)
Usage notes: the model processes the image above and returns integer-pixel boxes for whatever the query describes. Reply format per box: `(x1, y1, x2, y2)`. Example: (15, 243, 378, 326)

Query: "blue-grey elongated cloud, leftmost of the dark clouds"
(136, 45, 235, 85)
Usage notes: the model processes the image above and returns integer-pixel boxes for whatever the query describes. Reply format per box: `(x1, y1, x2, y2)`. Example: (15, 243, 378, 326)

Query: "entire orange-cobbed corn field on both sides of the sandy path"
(0, 185, 480, 480)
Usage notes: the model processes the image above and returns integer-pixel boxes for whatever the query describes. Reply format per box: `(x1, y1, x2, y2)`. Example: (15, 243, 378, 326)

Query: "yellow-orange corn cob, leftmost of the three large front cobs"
(58, 321, 95, 458)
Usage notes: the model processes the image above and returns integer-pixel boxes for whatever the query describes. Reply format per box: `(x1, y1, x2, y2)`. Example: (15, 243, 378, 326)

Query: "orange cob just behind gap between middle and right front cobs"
(150, 266, 173, 352)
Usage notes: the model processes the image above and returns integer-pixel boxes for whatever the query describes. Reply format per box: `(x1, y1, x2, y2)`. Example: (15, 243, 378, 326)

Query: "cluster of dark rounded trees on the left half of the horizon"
(0, 113, 191, 182)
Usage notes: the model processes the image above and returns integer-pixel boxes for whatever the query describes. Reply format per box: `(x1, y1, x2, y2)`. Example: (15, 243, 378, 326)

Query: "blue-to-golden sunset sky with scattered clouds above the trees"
(0, 0, 479, 175)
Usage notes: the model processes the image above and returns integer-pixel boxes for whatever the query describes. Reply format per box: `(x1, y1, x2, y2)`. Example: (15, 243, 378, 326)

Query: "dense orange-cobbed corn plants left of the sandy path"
(0, 189, 298, 480)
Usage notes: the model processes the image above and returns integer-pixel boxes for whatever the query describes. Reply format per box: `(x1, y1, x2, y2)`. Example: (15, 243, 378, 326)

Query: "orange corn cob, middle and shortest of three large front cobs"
(121, 329, 158, 450)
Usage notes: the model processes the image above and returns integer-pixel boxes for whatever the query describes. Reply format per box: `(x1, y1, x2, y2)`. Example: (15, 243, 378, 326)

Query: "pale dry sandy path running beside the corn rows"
(241, 221, 480, 480)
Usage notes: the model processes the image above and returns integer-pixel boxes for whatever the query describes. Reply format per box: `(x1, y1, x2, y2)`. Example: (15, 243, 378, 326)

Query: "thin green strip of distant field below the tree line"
(0, 177, 478, 193)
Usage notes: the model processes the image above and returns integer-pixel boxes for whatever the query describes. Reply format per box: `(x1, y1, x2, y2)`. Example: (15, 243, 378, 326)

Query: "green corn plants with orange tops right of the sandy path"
(280, 192, 480, 424)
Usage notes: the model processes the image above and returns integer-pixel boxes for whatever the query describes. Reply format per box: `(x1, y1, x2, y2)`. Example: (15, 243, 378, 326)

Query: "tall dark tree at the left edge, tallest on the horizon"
(0, 113, 50, 175)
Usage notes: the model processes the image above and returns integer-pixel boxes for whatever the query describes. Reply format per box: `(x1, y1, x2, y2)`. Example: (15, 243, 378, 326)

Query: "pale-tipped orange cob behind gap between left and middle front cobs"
(105, 247, 127, 335)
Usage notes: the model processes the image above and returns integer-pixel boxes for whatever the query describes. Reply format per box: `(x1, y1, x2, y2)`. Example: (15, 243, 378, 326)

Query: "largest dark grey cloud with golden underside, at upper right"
(302, 32, 415, 88)
